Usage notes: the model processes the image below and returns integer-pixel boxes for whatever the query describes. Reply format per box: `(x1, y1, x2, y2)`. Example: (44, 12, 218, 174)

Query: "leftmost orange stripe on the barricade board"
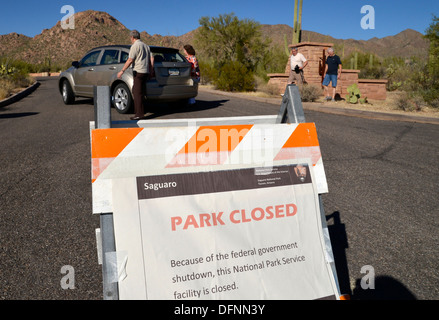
(91, 128, 143, 159)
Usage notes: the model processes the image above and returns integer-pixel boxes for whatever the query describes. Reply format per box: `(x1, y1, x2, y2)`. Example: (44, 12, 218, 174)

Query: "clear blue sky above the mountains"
(0, 0, 439, 40)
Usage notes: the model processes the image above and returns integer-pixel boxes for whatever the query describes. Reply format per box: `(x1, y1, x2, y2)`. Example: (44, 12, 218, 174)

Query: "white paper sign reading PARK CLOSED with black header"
(112, 163, 338, 300)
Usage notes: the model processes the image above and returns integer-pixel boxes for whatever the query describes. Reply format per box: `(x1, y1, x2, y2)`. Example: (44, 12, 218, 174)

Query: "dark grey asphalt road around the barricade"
(0, 79, 439, 300)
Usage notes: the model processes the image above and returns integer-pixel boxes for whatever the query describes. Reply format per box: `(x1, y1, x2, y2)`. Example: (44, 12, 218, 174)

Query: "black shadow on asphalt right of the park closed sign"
(326, 211, 417, 300)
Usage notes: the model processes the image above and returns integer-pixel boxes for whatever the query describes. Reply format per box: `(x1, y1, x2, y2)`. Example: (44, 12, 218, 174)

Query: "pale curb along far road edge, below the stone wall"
(199, 87, 439, 125)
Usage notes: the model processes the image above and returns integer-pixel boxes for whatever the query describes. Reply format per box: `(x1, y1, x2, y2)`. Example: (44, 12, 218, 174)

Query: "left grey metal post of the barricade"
(93, 86, 119, 300)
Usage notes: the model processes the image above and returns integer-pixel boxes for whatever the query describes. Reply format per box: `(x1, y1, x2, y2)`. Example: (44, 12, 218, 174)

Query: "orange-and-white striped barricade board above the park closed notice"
(91, 123, 328, 214)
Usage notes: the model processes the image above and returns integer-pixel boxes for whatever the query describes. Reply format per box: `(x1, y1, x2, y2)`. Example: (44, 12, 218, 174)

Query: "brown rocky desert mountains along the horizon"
(0, 10, 428, 66)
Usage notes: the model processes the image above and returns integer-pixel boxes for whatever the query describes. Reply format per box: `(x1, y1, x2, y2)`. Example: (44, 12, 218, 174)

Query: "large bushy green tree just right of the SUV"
(195, 13, 269, 91)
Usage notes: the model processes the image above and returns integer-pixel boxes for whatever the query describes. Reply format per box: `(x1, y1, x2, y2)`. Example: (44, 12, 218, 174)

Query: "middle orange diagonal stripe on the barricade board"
(179, 125, 253, 154)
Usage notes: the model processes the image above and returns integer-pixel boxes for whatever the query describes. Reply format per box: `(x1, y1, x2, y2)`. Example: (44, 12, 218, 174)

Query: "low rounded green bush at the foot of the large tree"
(214, 61, 255, 91)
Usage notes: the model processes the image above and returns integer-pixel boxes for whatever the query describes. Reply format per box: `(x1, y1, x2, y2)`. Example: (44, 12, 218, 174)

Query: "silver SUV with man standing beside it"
(59, 45, 198, 113)
